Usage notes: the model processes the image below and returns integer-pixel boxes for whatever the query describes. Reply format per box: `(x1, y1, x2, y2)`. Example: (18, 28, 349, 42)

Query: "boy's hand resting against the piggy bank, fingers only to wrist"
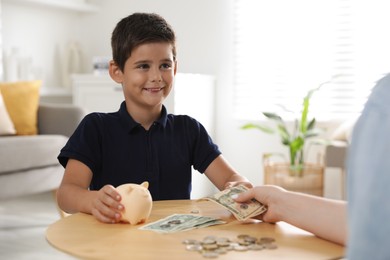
(91, 185, 124, 223)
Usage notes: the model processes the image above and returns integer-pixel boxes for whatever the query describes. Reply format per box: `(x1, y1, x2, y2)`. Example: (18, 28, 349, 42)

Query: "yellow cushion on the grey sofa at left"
(0, 80, 42, 135)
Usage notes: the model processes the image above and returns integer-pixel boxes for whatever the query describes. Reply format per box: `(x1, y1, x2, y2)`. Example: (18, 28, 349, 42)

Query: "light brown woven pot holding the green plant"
(264, 161, 324, 196)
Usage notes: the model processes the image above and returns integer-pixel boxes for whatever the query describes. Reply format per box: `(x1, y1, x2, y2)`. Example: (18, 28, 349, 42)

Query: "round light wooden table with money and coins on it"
(46, 200, 345, 260)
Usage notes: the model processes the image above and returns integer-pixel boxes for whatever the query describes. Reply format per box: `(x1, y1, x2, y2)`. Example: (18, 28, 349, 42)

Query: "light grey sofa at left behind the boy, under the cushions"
(0, 104, 86, 200)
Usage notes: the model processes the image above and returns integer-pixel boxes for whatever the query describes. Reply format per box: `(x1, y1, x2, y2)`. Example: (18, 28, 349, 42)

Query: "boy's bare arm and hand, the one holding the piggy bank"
(57, 159, 123, 223)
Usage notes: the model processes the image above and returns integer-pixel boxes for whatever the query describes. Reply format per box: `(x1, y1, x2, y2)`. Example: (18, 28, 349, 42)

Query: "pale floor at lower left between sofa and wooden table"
(0, 192, 75, 260)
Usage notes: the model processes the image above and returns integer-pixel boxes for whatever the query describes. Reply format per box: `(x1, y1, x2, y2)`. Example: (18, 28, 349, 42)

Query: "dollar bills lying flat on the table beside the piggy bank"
(139, 214, 226, 233)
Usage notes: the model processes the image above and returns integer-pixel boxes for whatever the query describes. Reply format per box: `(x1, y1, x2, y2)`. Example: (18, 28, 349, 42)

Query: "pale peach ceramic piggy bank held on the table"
(116, 182, 153, 225)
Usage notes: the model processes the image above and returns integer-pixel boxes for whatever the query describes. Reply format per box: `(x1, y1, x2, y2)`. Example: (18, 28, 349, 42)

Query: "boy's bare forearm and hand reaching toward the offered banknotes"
(205, 155, 252, 190)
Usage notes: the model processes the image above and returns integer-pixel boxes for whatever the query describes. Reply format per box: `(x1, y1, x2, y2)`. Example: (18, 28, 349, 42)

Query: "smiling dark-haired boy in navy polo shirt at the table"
(57, 13, 252, 223)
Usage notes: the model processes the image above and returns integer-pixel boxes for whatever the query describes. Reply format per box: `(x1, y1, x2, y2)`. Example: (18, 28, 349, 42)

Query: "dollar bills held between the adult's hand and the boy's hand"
(204, 185, 267, 221)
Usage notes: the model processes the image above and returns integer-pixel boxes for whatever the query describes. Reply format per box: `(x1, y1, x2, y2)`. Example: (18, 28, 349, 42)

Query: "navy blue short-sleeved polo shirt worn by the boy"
(58, 102, 221, 200)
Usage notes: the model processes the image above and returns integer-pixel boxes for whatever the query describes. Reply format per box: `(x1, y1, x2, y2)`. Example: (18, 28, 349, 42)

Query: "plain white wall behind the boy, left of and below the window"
(3, 0, 344, 197)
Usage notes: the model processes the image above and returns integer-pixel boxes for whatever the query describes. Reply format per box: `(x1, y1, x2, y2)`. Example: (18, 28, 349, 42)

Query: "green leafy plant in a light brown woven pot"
(241, 82, 327, 196)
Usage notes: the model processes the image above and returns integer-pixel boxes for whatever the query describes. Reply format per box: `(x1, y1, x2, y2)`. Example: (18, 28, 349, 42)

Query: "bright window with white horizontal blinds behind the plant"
(234, 0, 390, 120)
